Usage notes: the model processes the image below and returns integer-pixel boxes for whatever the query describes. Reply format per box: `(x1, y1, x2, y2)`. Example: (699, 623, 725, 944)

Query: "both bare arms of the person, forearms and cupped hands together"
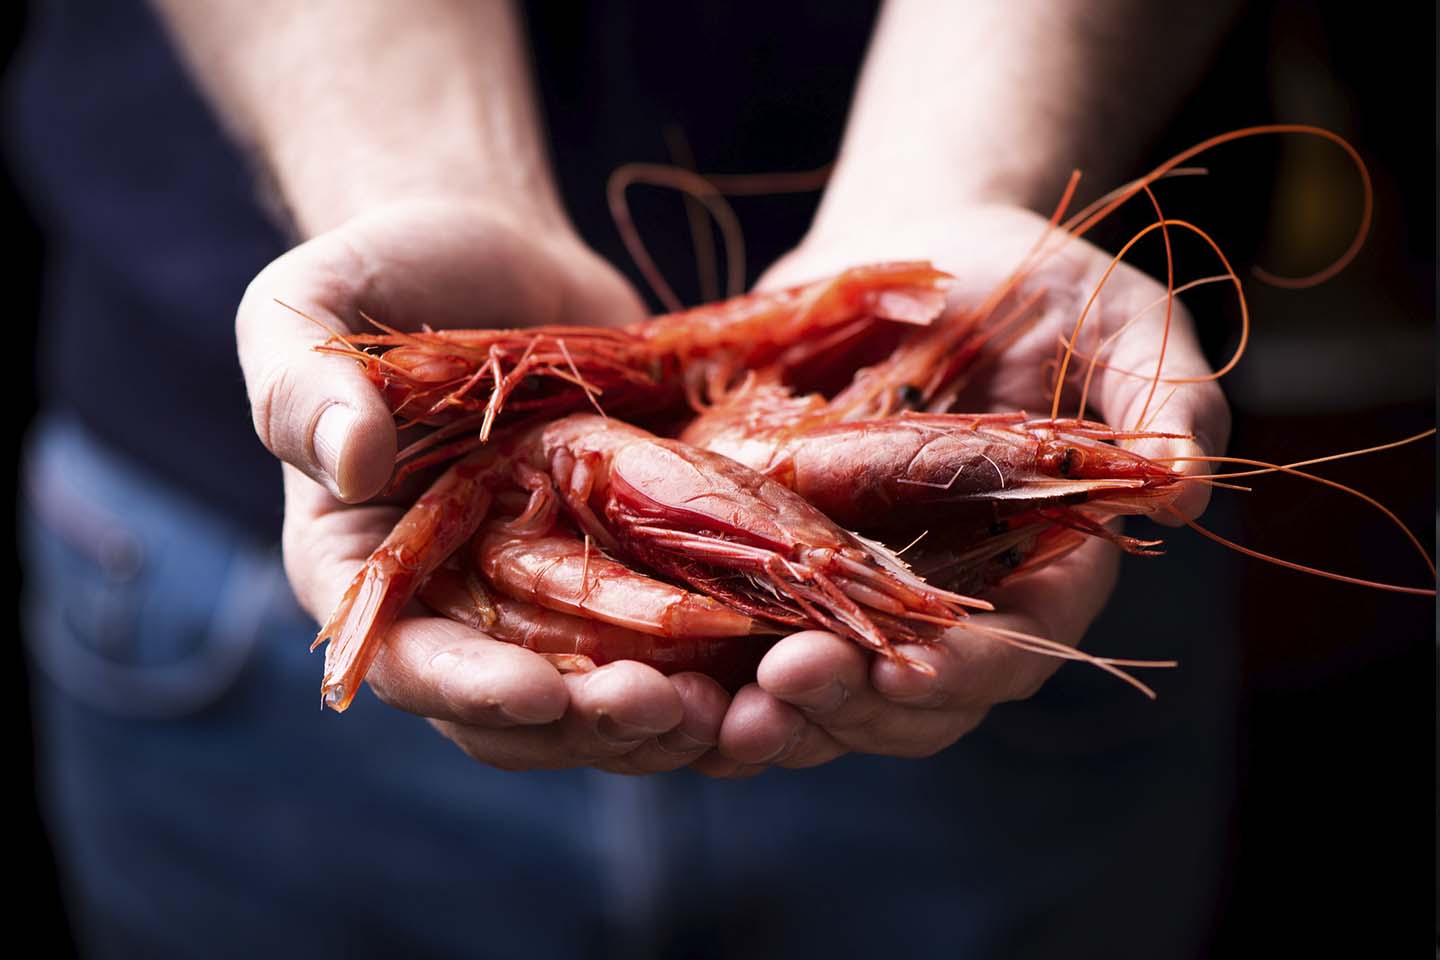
(156, 0, 1228, 776)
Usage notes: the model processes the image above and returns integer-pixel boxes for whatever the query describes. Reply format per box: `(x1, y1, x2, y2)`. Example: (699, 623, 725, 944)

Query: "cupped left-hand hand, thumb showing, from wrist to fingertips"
(236, 200, 729, 773)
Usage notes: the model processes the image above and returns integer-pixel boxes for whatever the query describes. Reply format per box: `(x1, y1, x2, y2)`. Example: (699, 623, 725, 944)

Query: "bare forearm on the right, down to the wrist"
(818, 0, 1234, 225)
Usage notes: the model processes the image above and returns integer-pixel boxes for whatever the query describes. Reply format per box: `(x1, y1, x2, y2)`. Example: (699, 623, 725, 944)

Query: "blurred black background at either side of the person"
(0, 3, 1436, 956)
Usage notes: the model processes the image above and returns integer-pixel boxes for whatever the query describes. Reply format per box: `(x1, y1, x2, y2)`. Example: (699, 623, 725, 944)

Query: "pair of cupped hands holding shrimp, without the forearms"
(236, 201, 1228, 777)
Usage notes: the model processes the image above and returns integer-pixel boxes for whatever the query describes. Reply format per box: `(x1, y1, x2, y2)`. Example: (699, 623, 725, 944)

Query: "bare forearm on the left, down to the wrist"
(154, 0, 563, 236)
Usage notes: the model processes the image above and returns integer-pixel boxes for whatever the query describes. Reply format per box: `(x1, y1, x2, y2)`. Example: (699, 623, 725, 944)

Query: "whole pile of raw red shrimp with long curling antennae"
(303, 127, 1434, 711)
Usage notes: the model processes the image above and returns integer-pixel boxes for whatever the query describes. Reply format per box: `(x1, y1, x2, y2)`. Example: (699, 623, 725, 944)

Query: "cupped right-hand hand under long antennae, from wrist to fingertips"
(697, 206, 1230, 776)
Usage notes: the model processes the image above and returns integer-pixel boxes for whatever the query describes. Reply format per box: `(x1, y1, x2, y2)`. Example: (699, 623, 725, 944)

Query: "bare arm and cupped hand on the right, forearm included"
(673, 0, 1234, 776)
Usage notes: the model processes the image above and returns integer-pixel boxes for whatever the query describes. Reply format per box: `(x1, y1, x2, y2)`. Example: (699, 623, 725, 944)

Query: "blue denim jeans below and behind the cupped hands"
(23, 419, 1233, 960)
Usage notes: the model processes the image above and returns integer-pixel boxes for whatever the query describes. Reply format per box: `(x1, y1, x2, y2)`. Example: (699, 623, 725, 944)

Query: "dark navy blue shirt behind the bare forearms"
(7, 0, 874, 537)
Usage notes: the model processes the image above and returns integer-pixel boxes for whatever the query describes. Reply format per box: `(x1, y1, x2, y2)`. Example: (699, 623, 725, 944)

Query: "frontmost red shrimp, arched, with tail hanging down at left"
(315, 415, 990, 710)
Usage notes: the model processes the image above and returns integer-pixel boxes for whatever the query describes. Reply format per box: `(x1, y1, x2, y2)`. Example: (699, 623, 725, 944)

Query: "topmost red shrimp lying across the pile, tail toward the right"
(308, 262, 949, 484)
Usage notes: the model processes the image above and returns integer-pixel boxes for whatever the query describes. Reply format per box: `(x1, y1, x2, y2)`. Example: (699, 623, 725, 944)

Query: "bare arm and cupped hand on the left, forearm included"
(156, 0, 729, 773)
